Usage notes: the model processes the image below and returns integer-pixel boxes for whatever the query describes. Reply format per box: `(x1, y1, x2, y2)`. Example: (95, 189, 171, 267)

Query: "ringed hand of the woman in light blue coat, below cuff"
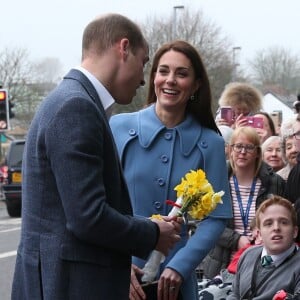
(157, 268, 182, 300)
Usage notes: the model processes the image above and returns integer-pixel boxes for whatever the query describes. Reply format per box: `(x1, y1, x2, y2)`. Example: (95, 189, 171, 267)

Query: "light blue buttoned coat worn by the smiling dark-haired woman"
(110, 105, 231, 300)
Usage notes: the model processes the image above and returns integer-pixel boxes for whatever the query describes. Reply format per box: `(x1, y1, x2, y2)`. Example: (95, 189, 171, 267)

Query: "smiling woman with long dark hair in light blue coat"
(110, 41, 231, 300)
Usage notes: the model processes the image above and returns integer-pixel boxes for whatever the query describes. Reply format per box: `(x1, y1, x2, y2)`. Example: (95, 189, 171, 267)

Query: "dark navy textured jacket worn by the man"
(12, 70, 158, 300)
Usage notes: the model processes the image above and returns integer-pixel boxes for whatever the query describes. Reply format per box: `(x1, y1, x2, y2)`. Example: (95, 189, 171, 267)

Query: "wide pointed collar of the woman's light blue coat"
(138, 104, 202, 155)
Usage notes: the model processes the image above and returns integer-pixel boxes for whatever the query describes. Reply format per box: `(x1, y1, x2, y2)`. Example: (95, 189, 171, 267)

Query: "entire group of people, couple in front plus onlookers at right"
(12, 14, 300, 300)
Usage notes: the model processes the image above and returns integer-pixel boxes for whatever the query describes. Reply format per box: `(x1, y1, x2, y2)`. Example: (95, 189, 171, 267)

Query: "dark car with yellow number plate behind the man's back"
(1, 140, 25, 217)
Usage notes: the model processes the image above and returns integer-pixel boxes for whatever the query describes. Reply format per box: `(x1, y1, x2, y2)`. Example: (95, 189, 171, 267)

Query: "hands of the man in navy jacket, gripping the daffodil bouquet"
(152, 216, 183, 256)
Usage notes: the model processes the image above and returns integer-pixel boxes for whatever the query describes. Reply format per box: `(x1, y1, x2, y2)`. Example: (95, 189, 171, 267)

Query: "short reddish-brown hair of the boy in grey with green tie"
(255, 195, 297, 228)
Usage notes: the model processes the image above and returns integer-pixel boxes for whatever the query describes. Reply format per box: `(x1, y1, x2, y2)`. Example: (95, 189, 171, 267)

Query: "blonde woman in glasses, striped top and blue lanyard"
(203, 127, 285, 279)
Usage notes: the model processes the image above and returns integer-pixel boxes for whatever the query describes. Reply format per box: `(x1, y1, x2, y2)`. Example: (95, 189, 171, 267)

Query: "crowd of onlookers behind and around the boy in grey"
(200, 82, 300, 300)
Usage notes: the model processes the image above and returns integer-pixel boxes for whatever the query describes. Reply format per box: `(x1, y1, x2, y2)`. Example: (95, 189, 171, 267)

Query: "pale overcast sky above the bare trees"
(0, 0, 300, 71)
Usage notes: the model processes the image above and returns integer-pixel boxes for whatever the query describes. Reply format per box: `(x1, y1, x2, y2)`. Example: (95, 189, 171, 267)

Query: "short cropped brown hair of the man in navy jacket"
(82, 14, 148, 59)
